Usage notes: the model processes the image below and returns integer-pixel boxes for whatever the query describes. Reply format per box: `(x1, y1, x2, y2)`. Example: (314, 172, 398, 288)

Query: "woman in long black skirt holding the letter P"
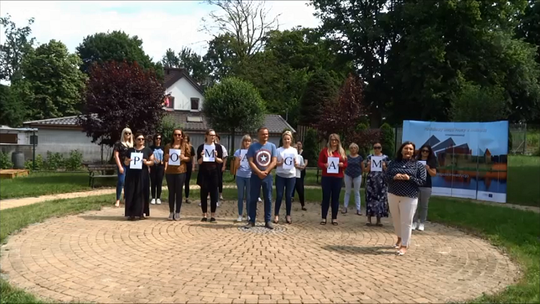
(124, 133, 154, 220)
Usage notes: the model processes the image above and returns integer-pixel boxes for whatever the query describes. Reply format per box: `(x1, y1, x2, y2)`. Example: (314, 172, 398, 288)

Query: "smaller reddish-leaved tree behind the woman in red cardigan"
(317, 74, 366, 144)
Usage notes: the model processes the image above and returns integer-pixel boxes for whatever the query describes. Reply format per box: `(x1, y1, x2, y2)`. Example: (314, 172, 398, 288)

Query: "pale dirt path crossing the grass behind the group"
(0, 184, 540, 213)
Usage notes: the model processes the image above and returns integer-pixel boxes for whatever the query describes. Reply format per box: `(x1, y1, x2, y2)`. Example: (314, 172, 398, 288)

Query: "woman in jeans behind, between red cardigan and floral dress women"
(343, 143, 364, 215)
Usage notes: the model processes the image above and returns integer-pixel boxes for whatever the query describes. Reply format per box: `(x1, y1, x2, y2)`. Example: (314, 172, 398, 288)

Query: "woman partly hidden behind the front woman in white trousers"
(412, 144, 437, 231)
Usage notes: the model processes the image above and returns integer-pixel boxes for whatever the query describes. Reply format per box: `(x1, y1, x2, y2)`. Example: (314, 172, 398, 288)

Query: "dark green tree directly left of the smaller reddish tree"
(298, 69, 339, 127)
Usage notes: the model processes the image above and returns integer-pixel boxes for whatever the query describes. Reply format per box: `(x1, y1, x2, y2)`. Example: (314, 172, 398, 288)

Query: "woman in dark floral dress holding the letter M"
(364, 142, 390, 226)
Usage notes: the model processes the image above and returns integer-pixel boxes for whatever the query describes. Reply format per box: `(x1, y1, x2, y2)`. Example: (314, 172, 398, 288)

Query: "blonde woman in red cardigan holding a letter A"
(318, 134, 347, 225)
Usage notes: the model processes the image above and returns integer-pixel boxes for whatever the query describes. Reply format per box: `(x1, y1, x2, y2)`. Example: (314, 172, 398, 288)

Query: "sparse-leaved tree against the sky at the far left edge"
(0, 14, 36, 81)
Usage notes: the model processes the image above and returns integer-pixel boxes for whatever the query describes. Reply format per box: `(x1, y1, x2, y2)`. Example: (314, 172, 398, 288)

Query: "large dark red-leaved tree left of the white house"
(79, 61, 165, 146)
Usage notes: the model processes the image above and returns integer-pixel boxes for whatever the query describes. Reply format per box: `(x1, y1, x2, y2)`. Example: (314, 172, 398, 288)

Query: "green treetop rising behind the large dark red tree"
(76, 31, 163, 79)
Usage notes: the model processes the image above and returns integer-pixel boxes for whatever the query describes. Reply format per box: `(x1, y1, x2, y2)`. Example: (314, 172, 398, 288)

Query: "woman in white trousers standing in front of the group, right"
(385, 141, 426, 255)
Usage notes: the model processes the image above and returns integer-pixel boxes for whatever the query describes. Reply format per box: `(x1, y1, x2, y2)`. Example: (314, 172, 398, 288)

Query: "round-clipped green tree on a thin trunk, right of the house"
(203, 77, 265, 151)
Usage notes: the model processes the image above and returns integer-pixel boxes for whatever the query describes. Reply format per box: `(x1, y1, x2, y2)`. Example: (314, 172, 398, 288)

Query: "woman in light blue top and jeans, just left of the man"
(234, 135, 251, 222)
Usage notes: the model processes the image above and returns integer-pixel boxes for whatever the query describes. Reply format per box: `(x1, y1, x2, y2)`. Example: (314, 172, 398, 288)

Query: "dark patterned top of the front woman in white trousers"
(385, 159, 426, 198)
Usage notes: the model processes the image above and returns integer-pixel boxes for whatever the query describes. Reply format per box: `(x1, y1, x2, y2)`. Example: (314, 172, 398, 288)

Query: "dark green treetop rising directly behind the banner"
(450, 83, 508, 122)
